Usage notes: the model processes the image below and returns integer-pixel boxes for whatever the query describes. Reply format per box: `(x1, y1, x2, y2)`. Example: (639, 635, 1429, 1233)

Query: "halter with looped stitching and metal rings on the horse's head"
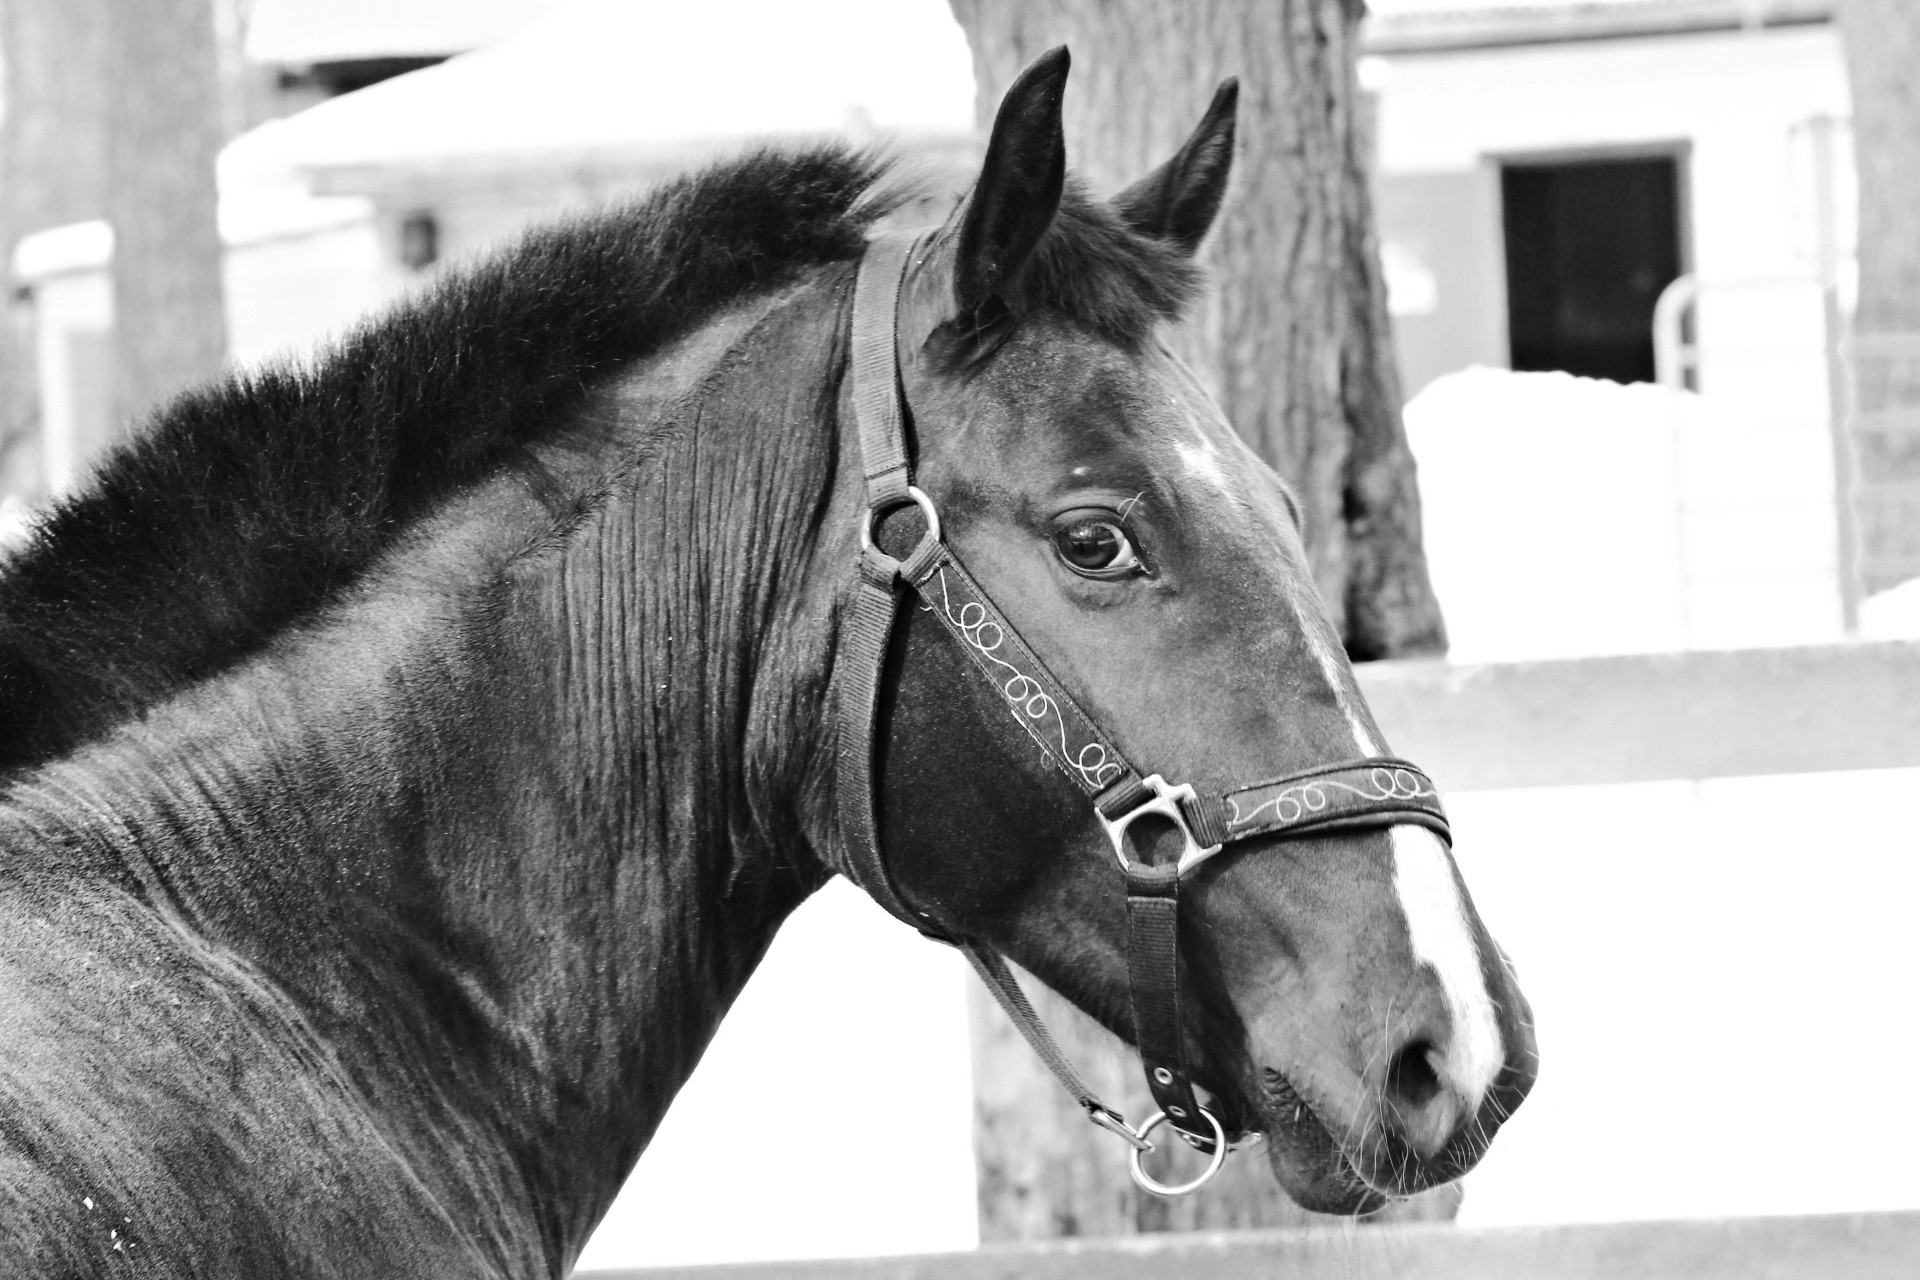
(835, 232, 1450, 1196)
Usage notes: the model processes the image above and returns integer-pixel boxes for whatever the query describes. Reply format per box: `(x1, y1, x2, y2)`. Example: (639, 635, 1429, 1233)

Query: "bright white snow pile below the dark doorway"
(1405, 367, 1841, 662)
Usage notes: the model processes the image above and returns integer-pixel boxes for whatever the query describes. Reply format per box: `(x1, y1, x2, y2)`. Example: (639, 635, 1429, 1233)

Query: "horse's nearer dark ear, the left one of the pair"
(954, 44, 1069, 313)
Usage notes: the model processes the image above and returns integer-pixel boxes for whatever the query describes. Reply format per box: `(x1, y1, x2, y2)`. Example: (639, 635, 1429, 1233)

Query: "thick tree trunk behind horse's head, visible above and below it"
(950, 0, 1459, 1240)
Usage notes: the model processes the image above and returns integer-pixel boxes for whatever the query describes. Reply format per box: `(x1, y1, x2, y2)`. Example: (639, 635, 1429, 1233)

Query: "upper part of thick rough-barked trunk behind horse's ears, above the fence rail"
(950, 0, 1446, 660)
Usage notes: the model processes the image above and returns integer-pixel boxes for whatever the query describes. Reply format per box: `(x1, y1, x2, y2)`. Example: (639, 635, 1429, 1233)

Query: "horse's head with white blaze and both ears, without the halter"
(856, 50, 1534, 1213)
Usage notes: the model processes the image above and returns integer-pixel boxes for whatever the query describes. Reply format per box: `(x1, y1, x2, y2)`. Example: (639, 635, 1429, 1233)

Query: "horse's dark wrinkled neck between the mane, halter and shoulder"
(0, 278, 845, 1265)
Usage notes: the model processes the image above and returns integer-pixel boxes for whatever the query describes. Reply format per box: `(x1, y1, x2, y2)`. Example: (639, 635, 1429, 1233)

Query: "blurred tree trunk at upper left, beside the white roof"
(106, 0, 227, 420)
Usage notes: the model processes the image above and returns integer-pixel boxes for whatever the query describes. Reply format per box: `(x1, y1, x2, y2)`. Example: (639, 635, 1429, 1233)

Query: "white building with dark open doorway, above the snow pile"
(1363, 0, 1853, 401)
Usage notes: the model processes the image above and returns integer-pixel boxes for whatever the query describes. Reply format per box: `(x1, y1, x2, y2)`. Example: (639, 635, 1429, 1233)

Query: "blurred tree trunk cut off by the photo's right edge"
(1839, 0, 1920, 591)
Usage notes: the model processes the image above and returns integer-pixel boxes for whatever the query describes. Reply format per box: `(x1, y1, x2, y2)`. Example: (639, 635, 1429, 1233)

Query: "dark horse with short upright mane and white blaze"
(0, 50, 1536, 1278)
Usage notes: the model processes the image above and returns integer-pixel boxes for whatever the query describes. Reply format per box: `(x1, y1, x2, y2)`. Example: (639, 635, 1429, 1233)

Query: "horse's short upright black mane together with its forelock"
(0, 144, 1196, 770)
